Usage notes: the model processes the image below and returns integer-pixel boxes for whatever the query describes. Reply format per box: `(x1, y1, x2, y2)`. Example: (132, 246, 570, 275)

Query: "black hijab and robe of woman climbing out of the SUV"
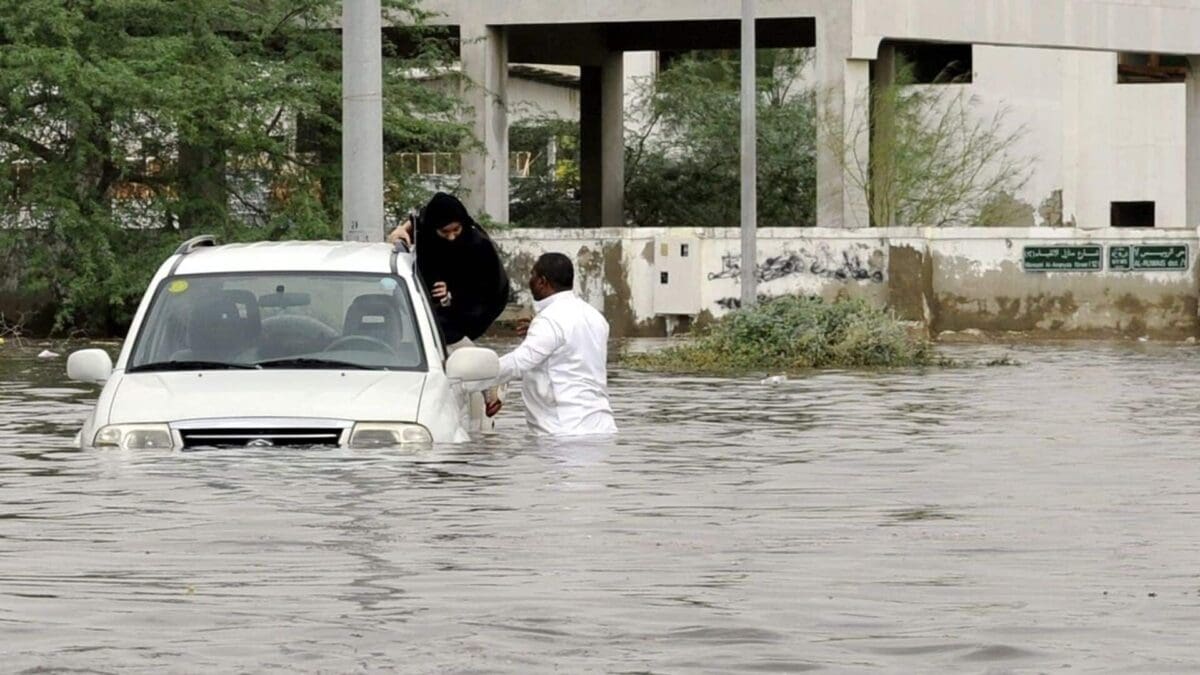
(416, 192, 509, 345)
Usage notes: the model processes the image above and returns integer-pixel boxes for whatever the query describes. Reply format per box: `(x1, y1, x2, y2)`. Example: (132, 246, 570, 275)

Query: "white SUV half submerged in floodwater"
(67, 237, 499, 449)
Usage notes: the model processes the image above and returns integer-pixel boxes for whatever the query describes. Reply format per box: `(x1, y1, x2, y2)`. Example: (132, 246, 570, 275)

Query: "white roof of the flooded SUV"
(167, 241, 413, 279)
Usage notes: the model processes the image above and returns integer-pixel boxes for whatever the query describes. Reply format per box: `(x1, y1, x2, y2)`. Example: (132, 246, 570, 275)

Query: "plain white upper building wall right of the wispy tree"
(960, 46, 1188, 229)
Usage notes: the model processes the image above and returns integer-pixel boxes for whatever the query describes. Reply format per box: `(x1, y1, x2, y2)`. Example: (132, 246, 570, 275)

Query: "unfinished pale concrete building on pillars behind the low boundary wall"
(417, 0, 1200, 228)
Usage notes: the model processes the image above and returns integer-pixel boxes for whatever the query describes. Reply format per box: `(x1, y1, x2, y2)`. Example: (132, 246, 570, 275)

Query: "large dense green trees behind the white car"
(0, 0, 467, 333)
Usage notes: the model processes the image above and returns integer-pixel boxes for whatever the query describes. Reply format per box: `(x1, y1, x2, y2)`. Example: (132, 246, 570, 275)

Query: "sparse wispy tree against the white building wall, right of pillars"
(822, 62, 1032, 226)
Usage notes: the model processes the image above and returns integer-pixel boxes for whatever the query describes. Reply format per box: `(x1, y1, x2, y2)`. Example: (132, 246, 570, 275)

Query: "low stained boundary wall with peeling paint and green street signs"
(496, 227, 1200, 339)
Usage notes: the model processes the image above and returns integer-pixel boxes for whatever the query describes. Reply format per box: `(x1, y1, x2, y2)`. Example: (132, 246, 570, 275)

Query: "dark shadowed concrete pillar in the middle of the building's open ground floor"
(580, 53, 625, 227)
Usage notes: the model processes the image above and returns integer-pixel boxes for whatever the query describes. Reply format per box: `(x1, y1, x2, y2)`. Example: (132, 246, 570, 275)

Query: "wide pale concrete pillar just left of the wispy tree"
(816, 19, 871, 227)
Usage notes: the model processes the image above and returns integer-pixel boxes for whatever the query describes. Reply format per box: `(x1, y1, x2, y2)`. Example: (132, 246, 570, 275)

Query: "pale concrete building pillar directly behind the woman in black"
(461, 25, 509, 222)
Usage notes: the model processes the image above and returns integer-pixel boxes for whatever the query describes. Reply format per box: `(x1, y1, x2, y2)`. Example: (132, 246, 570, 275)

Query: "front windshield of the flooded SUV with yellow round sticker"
(127, 273, 425, 372)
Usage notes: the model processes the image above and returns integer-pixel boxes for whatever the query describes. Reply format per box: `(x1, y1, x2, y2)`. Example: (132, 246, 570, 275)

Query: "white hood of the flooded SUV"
(108, 370, 426, 424)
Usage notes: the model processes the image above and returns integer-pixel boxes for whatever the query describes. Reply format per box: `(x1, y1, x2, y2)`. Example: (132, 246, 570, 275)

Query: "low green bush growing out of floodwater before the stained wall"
(625, 297, 934, 374)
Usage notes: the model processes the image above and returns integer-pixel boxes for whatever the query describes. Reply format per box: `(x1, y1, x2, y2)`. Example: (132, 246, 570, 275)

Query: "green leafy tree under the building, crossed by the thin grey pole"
(625, 49, 817, 227)
